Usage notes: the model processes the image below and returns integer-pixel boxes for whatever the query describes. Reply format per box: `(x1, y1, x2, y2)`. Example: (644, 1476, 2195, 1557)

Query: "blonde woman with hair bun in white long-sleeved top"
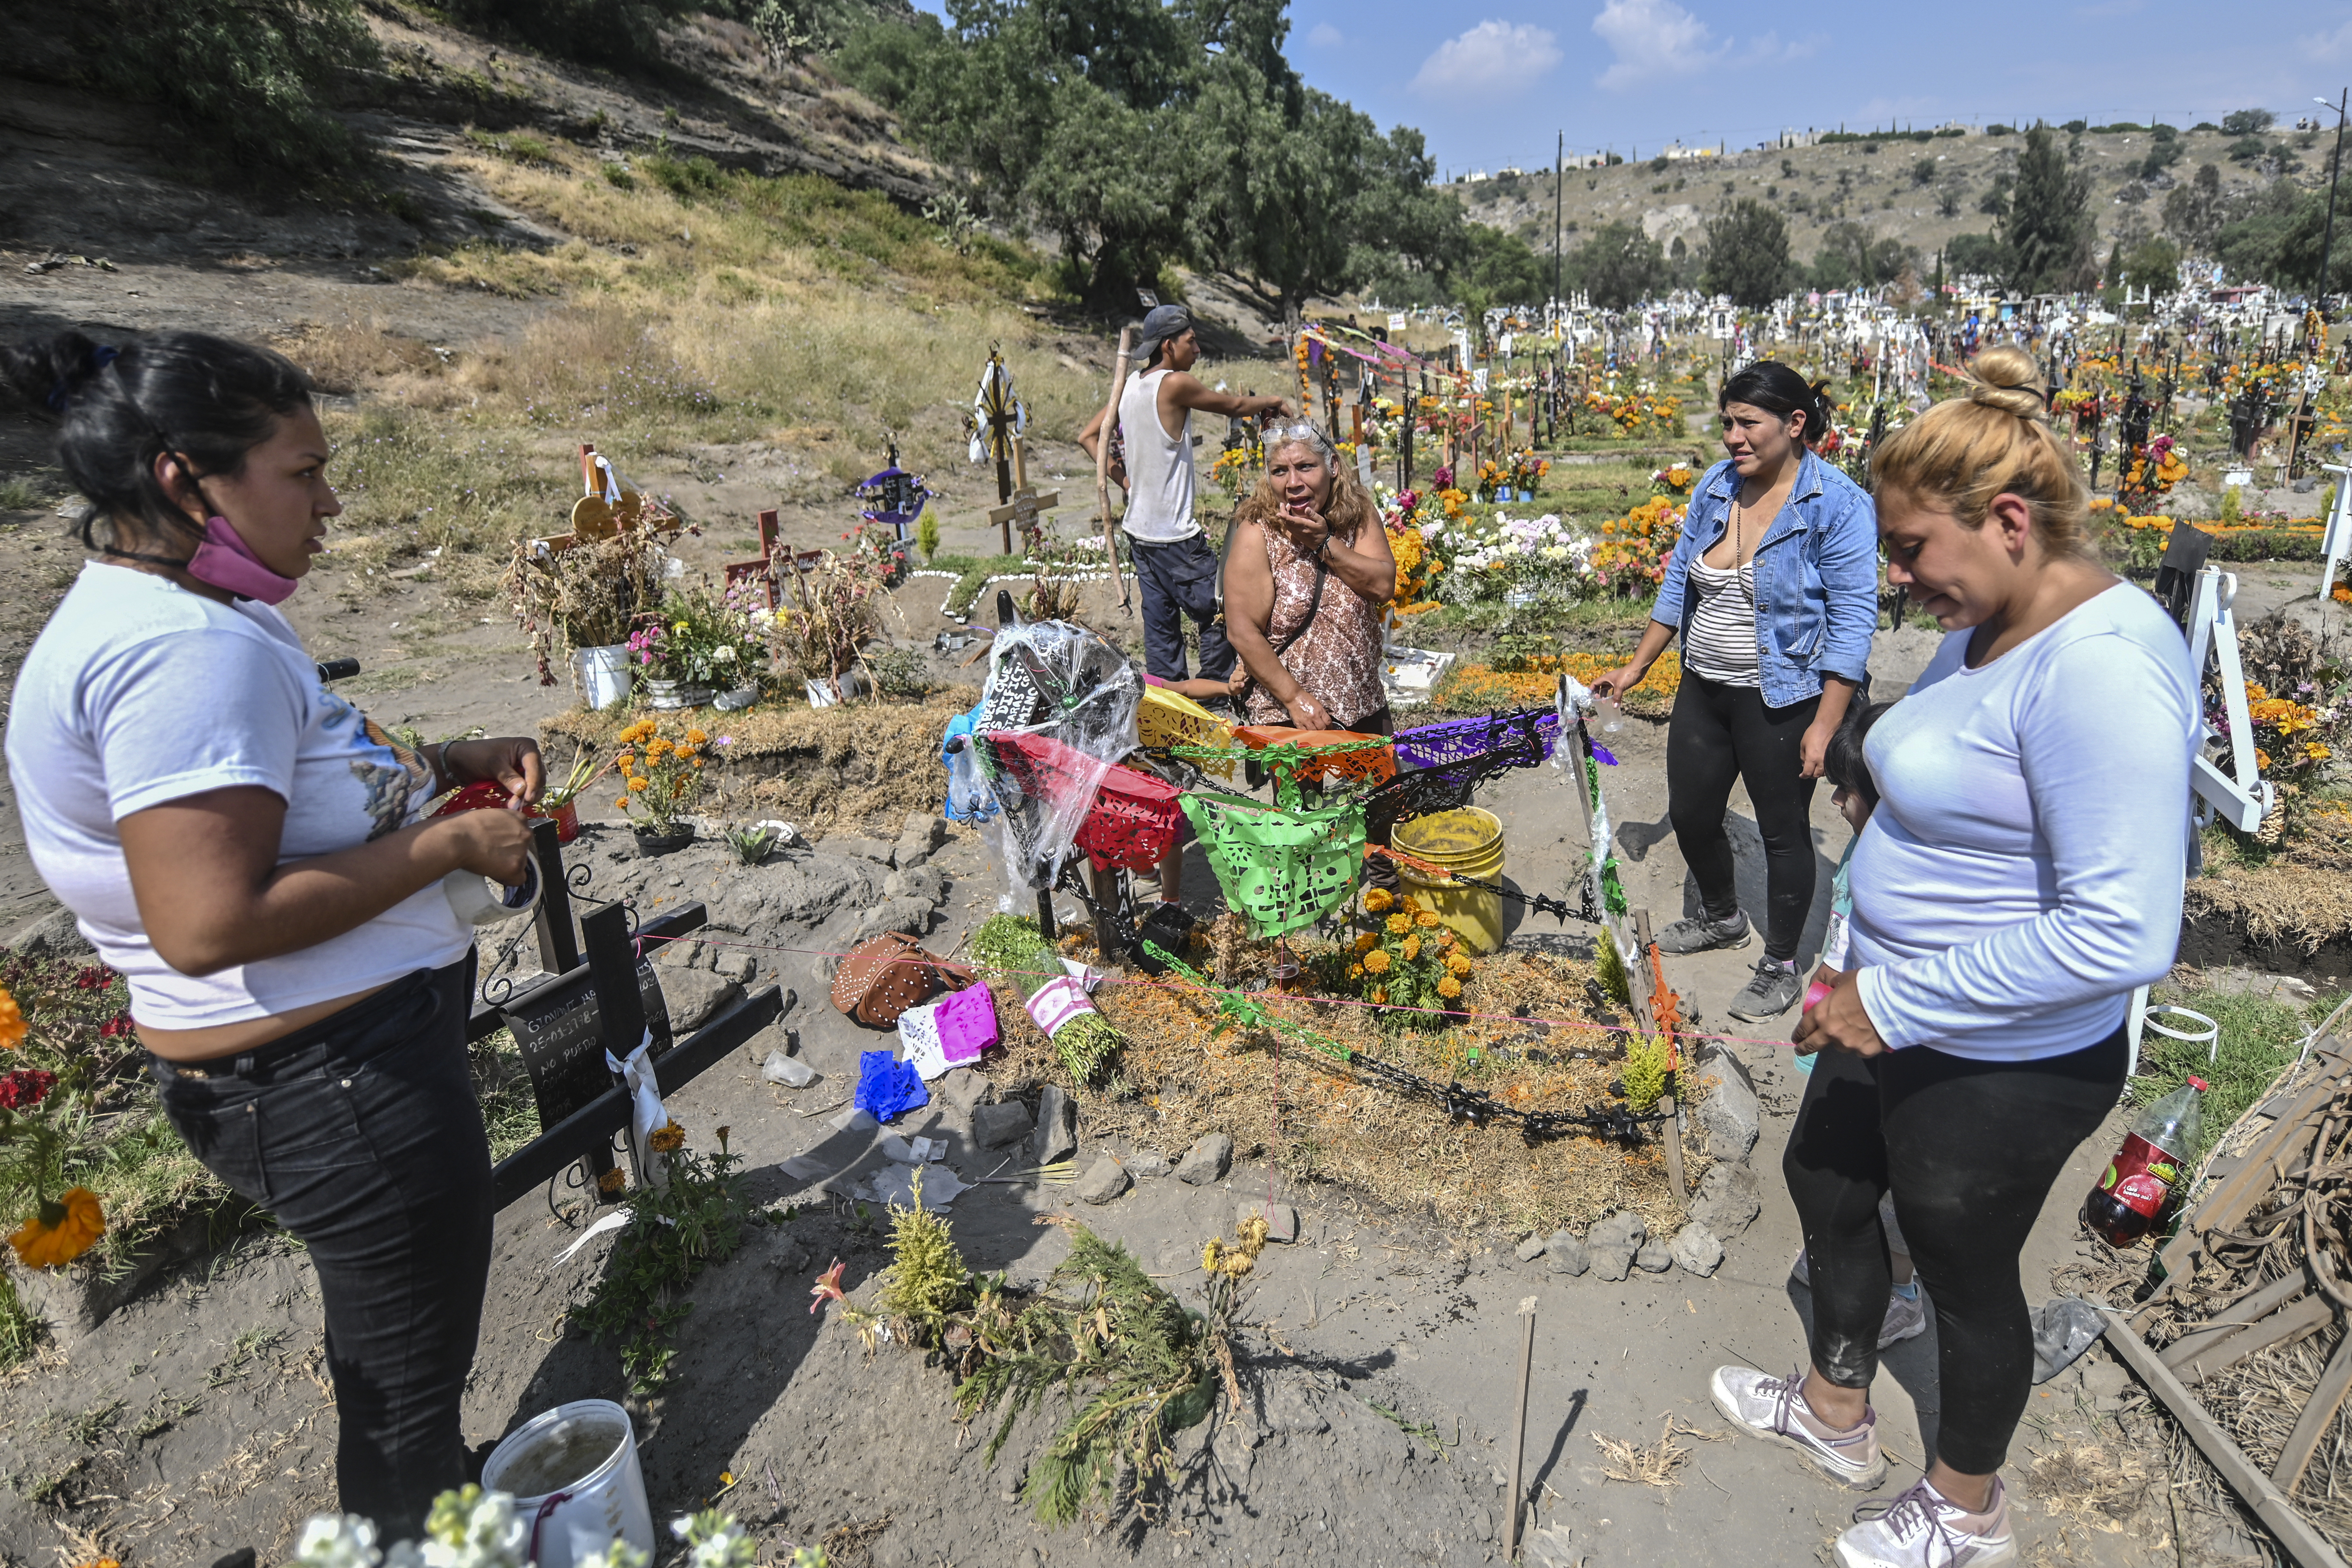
(1712, 348, 2199, 1568)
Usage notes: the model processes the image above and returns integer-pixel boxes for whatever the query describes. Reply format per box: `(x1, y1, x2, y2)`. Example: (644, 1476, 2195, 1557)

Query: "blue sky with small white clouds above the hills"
(917, 0, 2352, 174)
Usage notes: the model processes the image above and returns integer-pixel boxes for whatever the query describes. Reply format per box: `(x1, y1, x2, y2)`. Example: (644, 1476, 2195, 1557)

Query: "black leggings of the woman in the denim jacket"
(1665, 670, 1820, 961)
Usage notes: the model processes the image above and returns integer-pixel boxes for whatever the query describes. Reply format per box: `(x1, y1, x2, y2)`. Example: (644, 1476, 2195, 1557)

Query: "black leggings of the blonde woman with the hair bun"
(1780, 1030, 2128, 1476)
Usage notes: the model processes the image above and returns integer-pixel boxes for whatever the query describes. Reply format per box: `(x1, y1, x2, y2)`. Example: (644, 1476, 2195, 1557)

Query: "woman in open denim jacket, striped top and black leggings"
(1592, 359, 1879, 1022)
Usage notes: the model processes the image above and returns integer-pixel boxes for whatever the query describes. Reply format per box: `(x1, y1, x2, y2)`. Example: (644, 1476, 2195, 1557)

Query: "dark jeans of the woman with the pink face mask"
(148, 964, 494, 1540)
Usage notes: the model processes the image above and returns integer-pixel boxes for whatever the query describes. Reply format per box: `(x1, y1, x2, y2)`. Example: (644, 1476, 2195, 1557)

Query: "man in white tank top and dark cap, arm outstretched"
(1077, 306, 1291, 682)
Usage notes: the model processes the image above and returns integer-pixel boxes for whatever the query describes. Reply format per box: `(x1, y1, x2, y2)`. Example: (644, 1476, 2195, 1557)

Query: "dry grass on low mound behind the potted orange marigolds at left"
(539, 686, 979, 837)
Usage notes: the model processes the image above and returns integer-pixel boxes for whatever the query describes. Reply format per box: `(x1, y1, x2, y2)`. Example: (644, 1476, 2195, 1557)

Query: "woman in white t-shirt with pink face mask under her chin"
(0, 331, 541, 1537)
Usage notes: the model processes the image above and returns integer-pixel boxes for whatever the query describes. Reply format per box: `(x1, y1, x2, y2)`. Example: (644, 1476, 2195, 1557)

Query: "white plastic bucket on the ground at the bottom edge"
(482, 1399, 654, 1568)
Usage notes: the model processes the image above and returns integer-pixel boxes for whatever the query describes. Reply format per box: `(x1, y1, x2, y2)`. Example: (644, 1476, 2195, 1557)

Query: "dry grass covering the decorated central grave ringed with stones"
(997, 926, 1705, 1234)
